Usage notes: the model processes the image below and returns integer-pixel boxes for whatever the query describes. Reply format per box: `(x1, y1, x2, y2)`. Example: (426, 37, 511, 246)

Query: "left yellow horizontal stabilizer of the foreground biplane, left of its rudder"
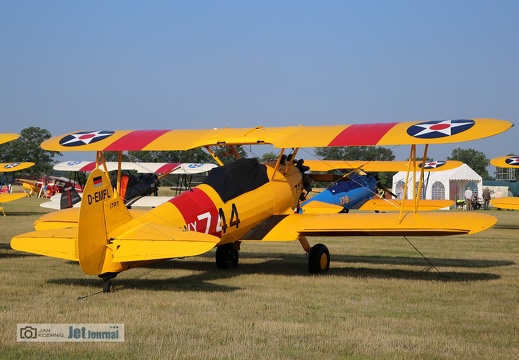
(11, 227, 79, 261)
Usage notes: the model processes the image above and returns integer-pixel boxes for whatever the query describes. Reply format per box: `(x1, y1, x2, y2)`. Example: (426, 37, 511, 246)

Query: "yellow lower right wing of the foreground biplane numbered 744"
(241, 212, 497, 241)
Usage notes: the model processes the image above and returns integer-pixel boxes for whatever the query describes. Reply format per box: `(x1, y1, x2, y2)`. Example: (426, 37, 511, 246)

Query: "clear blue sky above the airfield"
(0, 0, 519, 169)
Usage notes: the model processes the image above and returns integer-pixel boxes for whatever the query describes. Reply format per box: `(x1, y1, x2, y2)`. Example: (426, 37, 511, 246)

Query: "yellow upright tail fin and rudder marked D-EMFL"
(77, 169, 132, 275)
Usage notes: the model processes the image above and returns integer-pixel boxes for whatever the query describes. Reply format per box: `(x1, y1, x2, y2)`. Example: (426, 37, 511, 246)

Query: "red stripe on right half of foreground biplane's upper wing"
(328, 122, 398, 146)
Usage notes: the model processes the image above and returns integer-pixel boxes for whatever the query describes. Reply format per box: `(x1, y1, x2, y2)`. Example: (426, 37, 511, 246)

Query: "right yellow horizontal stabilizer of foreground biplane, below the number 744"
(109, 223, 220, 262)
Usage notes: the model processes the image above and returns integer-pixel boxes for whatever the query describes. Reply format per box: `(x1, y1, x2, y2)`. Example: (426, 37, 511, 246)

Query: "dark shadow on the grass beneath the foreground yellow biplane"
(43, 253, 508, 292)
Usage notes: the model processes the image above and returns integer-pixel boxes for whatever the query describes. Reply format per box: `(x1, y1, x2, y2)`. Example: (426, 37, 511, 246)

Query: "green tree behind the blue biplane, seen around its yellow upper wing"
(310, 146, 395, 188)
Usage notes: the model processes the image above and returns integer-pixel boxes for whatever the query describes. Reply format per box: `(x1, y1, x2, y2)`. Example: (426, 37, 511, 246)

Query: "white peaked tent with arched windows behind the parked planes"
(393, 164, 483, 208)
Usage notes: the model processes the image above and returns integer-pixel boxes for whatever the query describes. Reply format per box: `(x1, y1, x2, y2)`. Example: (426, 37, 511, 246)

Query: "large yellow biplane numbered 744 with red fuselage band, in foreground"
(11, 118, 512, 291)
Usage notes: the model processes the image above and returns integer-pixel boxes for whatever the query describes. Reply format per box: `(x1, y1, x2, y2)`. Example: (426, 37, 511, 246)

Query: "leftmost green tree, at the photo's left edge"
(0, 126, 61, 176)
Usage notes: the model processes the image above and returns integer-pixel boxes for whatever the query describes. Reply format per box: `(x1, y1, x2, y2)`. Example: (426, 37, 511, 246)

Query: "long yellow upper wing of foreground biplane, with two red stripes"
(41, 118, 513, 151)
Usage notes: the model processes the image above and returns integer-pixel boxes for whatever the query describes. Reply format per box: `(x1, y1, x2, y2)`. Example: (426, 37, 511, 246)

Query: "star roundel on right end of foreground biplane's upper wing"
(407, 119, 474, 139)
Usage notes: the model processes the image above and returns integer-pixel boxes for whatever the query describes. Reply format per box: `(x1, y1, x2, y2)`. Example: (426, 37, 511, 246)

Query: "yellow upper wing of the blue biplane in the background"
(305, 160, 463, 172)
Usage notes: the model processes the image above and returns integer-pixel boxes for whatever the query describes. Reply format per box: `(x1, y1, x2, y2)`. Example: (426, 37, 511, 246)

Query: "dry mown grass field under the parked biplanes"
(0, 198, 519, 359)
